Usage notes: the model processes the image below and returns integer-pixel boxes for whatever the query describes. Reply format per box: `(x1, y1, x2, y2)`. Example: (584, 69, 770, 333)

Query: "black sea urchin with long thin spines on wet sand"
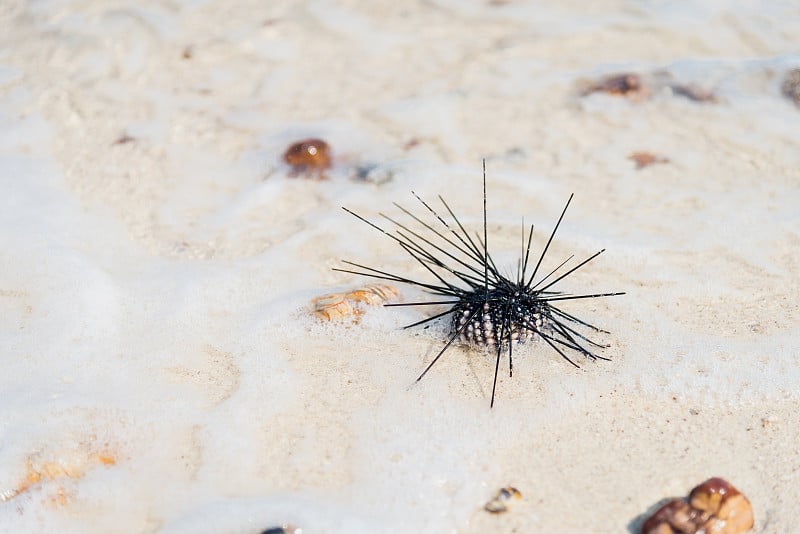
(334, 161, 624, 406)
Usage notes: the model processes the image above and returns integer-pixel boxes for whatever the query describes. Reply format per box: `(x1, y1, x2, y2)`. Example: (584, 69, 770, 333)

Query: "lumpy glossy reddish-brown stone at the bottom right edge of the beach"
(642, 477, 754, 534)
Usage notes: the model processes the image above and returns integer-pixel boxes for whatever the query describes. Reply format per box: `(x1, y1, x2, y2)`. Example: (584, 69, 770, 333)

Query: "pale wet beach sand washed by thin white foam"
(0, 0, 800, 533)
